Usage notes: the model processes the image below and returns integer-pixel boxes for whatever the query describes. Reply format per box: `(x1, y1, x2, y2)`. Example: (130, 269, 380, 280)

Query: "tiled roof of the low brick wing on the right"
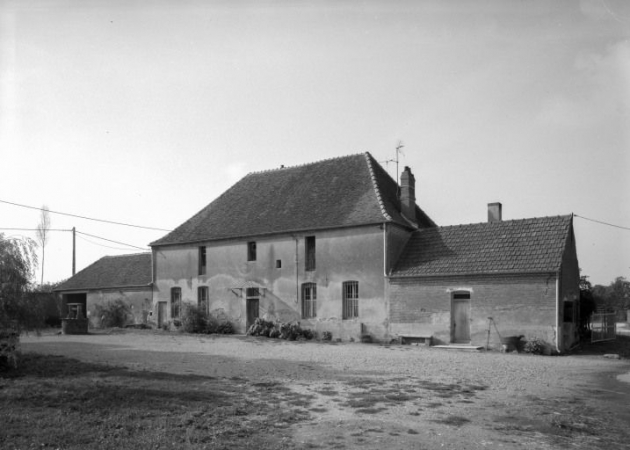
(392, 215, 572, 277)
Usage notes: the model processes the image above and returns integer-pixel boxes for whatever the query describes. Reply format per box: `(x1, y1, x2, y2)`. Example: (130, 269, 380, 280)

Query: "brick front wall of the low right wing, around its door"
(389, 274, 557, 347)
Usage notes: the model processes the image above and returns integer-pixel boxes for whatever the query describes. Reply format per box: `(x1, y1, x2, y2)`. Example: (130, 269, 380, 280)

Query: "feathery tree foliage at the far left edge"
(0, 233, 41, 329)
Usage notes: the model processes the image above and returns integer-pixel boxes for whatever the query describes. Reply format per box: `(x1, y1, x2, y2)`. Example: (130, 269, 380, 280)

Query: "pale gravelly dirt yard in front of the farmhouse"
(17, 330, 630, 450)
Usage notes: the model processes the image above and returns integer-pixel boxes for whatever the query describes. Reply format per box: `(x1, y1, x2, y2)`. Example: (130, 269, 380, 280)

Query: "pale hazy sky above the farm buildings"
(0, 0, 630, 284)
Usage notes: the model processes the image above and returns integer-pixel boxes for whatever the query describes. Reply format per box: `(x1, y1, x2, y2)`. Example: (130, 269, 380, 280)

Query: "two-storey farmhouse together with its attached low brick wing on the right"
(151, 153, 579, 351)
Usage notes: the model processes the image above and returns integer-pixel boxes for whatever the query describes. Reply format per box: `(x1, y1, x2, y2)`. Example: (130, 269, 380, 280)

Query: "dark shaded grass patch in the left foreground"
(0, 354, 310, 450)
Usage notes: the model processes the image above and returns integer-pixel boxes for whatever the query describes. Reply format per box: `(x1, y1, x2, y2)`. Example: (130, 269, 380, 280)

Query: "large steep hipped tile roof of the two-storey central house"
(151, 153, 435, 245)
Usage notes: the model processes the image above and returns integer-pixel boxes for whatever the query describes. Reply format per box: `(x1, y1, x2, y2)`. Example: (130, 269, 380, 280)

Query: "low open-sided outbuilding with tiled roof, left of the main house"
(55, 253, 153, 331)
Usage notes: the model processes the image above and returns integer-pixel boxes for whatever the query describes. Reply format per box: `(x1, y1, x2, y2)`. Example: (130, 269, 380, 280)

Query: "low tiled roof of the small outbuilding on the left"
(55, 253, 151, 291)
